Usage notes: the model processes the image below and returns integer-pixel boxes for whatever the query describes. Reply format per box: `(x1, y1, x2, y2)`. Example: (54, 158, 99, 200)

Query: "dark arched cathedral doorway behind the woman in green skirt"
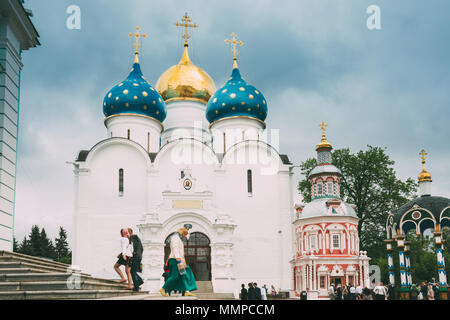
(164, 232, 211, 281)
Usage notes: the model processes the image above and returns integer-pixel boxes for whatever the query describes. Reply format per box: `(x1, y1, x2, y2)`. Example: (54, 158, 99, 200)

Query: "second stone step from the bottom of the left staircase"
(0, 280, 127, 291)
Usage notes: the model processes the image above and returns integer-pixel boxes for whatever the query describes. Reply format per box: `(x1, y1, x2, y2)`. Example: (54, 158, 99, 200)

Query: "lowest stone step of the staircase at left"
(0, 290, 148, 300)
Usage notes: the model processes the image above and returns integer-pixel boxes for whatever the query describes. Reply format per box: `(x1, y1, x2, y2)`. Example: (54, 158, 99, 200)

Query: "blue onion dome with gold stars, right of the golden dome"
(206, 66, 267, 123)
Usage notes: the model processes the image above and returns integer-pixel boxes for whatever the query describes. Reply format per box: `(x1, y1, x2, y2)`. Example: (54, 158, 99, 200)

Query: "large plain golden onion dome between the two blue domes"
(155, 44, 216, 104)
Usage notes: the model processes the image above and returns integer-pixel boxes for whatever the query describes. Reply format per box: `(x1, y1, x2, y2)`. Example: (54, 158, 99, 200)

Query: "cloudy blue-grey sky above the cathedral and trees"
(16, 0, 450, 244)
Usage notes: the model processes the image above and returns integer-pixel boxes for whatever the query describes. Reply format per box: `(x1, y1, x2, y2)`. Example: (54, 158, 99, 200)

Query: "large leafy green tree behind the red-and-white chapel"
(298, 146, 417, 259)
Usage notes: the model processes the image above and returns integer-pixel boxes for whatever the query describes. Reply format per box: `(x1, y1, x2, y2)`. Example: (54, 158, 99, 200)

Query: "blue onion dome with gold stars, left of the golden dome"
(103, 61, 166, 122)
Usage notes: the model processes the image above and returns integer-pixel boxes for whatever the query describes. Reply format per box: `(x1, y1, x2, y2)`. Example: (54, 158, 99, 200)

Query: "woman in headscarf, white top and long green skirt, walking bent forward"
(159, 228, 197, 297)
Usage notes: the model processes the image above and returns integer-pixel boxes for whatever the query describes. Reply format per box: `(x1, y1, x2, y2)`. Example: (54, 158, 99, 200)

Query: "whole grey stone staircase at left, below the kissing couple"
(0, 251, 148, 300)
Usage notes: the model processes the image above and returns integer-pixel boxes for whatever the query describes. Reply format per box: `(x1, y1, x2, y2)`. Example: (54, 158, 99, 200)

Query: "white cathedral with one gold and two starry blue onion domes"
(73, 23, 295, 293)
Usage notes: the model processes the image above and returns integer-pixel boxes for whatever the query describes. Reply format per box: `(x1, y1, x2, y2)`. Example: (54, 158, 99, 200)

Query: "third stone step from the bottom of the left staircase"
(0, 272, 127, 287)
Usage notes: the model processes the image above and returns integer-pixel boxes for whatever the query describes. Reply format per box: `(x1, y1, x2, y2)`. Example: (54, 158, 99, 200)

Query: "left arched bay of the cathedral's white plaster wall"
(73, 139, 150, 278)
